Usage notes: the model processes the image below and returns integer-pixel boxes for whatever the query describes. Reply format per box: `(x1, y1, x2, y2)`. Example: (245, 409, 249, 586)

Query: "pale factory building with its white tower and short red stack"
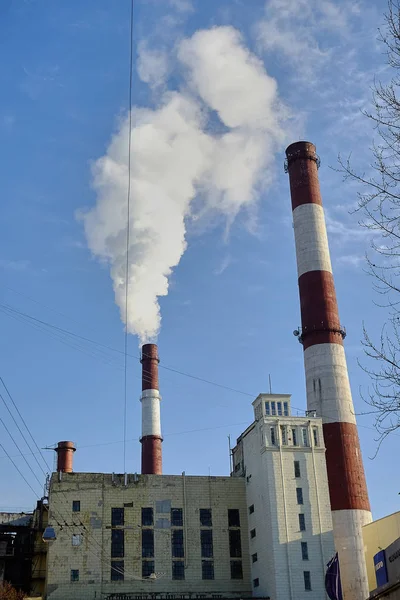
(47, 390, 335, 600)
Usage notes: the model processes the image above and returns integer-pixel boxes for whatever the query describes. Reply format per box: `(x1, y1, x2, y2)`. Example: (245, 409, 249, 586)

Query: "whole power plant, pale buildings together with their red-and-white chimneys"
(1, 142, 371, 600)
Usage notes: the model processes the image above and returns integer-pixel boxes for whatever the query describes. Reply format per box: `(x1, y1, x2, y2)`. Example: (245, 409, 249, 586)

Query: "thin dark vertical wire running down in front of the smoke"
(124, 0, 133, 473)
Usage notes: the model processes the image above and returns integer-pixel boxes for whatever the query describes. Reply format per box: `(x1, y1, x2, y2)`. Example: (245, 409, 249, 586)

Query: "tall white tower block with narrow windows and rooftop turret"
(233, 394, 335, 600)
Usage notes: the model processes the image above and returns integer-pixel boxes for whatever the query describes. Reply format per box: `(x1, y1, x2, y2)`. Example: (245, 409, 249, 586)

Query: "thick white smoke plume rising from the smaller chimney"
(83, 27, 286, 343)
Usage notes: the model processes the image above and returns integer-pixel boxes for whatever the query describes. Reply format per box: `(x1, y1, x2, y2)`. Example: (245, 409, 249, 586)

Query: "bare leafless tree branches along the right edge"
(339, 0, 400, 448)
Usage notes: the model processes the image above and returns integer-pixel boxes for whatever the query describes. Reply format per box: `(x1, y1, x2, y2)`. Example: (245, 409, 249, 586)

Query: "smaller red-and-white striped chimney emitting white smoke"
(140, 344, 162, 475)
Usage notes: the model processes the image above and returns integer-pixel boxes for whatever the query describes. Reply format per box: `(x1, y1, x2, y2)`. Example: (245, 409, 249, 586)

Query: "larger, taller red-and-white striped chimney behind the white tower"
(285, 142, 372, 600)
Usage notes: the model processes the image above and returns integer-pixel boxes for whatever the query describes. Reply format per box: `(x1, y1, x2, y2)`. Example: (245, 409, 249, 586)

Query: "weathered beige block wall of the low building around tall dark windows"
(47, 473, 251, 600)
